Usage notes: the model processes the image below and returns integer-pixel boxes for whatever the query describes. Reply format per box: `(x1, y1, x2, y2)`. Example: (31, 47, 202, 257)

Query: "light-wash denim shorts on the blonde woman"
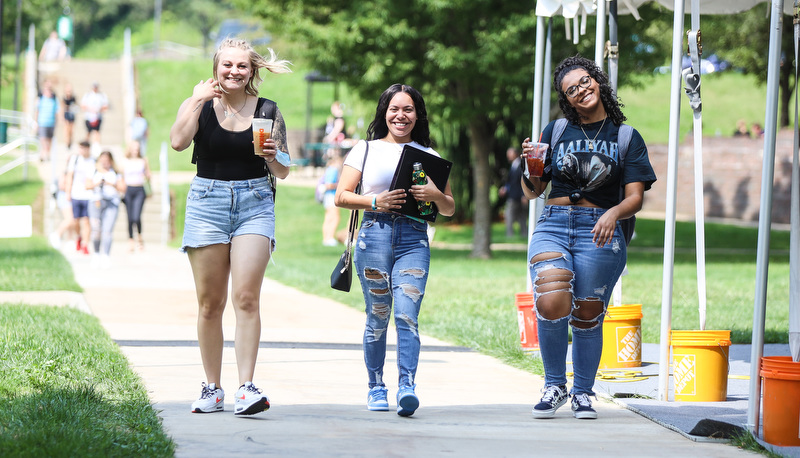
(181, 176, 275, 253)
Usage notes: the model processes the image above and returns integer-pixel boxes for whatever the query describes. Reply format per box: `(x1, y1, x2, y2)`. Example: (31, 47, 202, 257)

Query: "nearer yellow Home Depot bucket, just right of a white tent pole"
(671, 330, 731, 402)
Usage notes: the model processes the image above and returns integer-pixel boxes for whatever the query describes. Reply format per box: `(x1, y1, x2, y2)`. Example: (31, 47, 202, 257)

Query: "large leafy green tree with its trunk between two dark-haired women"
(239, 0, 535, 258)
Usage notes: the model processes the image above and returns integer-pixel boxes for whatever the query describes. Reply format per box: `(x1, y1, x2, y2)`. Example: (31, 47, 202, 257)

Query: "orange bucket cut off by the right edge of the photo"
(761, 356, 800, 447)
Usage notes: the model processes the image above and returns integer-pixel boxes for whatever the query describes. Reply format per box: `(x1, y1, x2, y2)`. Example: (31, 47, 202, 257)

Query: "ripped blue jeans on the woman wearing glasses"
(528, 205, 627, 395)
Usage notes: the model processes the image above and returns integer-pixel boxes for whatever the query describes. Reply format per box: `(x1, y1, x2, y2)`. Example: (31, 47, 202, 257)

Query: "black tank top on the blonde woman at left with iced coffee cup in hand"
(194, 101, 268, 181)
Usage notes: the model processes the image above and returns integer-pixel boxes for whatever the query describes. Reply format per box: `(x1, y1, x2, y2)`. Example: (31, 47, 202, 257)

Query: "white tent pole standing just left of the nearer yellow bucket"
(658, 0, 685, 401)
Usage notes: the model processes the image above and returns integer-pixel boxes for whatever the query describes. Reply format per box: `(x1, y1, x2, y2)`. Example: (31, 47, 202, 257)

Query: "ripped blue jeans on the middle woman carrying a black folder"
(353, 212, 431, 388)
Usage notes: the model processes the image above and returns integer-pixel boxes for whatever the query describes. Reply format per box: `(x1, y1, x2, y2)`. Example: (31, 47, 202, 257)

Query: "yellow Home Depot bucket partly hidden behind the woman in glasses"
(600, 304, 642, 369)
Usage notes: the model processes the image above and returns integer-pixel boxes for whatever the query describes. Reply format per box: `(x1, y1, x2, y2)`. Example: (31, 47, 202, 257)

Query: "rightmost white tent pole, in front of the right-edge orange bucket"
(747, 0, 783, 437)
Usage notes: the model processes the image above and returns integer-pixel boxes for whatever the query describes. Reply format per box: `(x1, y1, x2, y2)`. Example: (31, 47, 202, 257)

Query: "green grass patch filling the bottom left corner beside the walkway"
(0, 304, 175, 457)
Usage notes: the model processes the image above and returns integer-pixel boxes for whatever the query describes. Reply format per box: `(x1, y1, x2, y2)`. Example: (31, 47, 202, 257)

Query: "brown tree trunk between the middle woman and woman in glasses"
(469, 119, 492, 259)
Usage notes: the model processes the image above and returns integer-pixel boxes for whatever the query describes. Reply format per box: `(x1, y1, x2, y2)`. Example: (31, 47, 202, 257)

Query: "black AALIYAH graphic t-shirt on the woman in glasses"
(541, 119, 656, 208)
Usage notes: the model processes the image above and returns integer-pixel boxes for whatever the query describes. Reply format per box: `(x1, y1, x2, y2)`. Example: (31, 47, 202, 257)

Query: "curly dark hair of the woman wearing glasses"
(553, 54, 628, 126)
